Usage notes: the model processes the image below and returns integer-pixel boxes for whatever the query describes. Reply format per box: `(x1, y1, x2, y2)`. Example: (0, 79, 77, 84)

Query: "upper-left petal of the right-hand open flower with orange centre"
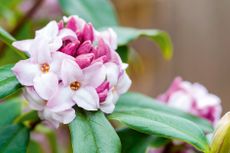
(61, 60, 83, 86)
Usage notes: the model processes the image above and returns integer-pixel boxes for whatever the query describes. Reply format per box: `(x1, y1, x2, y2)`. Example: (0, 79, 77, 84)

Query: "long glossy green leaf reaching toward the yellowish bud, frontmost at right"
(109, 107, 209, 151)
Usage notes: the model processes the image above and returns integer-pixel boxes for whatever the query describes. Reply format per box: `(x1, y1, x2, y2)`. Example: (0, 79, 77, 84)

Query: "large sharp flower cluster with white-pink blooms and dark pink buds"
(12, 16, 131, 127)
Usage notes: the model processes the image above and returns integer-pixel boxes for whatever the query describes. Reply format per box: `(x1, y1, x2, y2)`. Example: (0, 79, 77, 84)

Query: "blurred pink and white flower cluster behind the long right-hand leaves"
(158, 77, 222, 125)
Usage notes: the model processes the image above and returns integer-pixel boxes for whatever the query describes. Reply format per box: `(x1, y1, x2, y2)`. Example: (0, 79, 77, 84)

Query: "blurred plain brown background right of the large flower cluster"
(114, 0, 230, 112)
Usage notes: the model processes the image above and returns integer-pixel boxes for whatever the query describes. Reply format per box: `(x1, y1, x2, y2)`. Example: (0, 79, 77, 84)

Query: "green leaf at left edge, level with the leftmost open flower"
(0, 65, 22, 99)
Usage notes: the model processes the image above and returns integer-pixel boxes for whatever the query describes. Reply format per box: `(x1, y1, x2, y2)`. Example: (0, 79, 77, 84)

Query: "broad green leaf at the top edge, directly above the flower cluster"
(59, 0, 118, 28)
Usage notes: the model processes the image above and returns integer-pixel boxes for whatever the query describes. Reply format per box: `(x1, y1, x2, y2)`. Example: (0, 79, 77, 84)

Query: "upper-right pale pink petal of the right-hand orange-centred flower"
(83, 62, 106, 88)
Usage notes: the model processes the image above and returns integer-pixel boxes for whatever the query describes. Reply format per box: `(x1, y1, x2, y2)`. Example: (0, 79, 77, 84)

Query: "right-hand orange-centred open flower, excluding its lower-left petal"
(58, 60, 105, 110)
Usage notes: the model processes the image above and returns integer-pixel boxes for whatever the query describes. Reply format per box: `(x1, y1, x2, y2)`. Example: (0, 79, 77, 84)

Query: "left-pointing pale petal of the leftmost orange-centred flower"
(12, 59, 41, 86)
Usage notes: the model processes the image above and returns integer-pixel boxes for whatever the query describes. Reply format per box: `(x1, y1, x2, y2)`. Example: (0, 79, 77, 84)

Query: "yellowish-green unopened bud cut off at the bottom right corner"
(210, 112, 230, 153)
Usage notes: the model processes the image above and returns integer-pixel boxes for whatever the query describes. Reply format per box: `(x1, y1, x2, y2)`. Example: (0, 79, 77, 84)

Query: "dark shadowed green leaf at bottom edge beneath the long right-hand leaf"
(117, 128, 168, 153)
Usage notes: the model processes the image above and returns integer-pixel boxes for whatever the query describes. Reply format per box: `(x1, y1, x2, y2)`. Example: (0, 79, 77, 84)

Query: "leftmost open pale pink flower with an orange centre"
(12, 40, 65, 99)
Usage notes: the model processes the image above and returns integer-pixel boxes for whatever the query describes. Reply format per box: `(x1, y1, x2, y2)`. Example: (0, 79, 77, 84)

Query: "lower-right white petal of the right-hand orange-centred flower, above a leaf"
(73, 87, 99, 110)
